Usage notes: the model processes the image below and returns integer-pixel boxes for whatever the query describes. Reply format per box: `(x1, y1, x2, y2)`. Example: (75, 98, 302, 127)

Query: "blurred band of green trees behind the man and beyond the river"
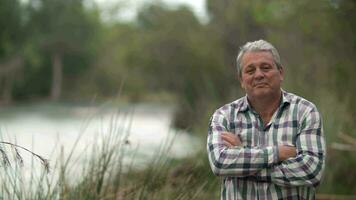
(0, 0, 356, 193)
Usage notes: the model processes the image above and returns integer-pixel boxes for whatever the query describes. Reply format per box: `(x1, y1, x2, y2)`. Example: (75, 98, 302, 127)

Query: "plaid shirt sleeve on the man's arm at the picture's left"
(207, 110, 278, 177)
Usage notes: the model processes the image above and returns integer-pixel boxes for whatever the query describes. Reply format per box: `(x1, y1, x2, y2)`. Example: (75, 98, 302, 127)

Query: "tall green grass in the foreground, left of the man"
(0, 104, 219, 200)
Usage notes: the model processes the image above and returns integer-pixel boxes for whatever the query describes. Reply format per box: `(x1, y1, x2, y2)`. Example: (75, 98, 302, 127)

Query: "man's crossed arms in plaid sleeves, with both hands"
(207, 108, 325, 186)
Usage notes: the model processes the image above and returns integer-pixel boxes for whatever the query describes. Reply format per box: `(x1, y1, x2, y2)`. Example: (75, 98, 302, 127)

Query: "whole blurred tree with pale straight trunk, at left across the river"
(29, 0, 99, 100)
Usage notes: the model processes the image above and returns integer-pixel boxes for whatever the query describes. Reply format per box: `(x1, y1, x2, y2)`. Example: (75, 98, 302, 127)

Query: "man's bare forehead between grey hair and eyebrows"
(241, 51, 274, 67)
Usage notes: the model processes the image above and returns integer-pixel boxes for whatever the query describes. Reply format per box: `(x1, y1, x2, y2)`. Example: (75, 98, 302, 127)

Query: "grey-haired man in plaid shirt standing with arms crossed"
(207, 40, 325, 200)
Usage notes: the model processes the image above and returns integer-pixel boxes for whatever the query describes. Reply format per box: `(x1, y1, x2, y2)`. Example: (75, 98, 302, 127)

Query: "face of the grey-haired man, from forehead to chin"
(240, 51, 283, 98)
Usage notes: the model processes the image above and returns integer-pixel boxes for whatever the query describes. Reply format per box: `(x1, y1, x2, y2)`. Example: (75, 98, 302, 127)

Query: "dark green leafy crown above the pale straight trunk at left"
(29, 0, 96, 52)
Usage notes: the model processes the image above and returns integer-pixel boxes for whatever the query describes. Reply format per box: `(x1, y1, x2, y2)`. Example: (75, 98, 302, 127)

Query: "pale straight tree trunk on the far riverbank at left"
(51, 52, 62, 101)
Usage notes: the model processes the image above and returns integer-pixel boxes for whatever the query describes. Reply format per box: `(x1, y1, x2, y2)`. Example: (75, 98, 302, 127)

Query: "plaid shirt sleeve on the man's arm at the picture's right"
(257, 108, 326, 187)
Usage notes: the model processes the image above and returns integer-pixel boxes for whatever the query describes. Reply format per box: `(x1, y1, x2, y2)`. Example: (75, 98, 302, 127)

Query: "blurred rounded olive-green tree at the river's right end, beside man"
(135, 5, 229, 129)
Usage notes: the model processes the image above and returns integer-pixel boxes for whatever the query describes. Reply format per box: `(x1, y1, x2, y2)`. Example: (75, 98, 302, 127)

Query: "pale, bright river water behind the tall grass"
(0, 103, 202, 182)
